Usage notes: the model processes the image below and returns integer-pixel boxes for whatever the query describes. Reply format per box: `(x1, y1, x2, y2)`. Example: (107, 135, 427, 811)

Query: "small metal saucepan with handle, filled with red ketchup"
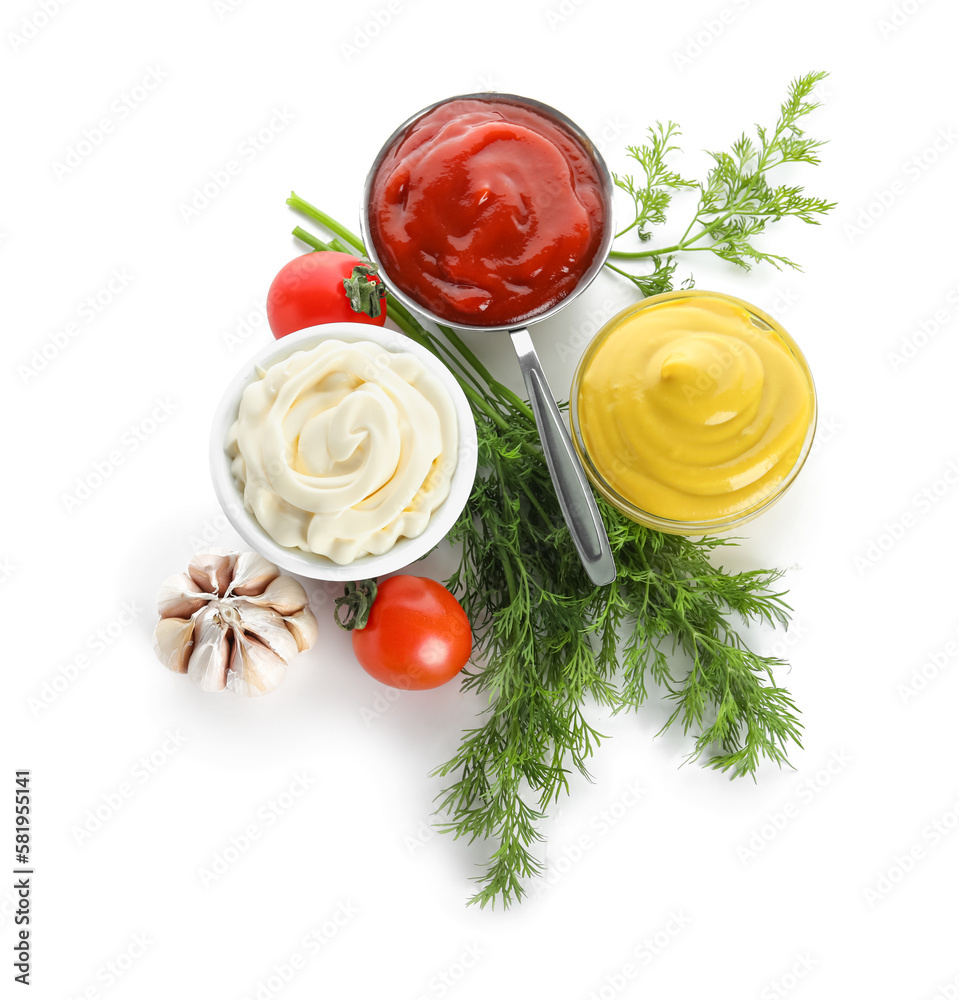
(361, 93, 616, 584)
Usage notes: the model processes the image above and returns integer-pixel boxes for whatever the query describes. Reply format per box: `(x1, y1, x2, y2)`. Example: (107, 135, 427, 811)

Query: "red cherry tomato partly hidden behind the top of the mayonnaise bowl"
(266, 250, 386, 340)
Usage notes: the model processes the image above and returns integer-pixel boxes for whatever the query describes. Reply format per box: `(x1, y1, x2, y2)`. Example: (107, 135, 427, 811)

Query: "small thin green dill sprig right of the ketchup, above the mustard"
(607, 72, 836, 295)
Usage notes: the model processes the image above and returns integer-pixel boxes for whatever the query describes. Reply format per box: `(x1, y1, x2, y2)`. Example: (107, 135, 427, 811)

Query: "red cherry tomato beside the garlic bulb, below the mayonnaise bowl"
(353, 576, 473, 691)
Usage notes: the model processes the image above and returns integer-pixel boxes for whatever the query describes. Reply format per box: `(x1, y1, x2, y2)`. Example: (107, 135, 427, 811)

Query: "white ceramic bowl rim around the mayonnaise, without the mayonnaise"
(210, 323, 476, 580)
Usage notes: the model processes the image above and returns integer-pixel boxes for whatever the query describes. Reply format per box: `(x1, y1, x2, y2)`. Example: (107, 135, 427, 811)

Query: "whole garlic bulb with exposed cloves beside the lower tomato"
(153, 549, 317, 695)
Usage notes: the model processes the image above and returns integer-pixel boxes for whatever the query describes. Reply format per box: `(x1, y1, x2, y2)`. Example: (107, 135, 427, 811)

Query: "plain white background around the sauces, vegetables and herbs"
(0, 0, 959, 1000)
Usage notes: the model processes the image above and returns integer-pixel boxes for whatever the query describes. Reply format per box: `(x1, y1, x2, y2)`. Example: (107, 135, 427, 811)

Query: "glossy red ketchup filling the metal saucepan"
(368, 98, 607, 326)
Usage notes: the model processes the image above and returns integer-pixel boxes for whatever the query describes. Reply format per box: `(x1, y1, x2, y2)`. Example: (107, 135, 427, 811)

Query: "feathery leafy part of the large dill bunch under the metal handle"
(436, 413, 801, 906)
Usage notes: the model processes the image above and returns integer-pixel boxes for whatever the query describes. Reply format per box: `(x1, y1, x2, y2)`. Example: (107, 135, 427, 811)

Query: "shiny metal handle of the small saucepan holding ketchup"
(510, 327, 616, 586)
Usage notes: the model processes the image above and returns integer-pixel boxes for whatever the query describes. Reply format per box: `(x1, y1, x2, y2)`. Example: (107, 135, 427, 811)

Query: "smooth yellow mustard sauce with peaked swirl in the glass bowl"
(576, 291, 814, 522)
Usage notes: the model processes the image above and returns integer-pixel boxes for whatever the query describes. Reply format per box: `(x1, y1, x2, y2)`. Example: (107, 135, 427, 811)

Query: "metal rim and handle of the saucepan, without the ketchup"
(360, 93, 616, 586)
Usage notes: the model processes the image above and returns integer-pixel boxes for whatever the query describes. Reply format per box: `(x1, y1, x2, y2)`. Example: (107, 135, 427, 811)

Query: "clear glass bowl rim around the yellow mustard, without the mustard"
(570, 289, 817, 535)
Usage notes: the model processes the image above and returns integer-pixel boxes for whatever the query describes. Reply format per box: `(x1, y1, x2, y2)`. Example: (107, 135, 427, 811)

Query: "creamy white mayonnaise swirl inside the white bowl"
(227, 340, 458, 565)
